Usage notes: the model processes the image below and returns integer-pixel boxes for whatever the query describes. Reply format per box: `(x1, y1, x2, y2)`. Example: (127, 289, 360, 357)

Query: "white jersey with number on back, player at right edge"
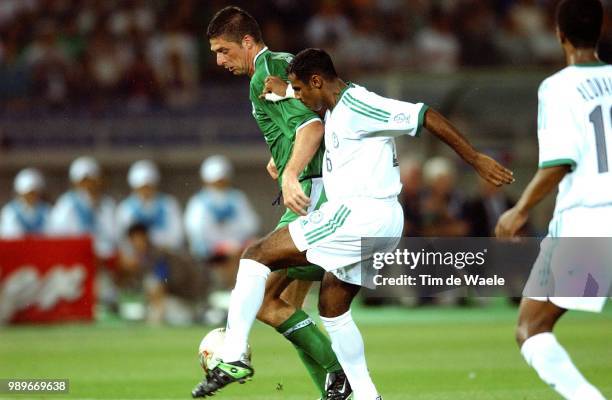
(538, 63, 612, 215)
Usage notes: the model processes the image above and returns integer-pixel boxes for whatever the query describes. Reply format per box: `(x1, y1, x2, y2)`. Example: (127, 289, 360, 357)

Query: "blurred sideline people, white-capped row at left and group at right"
(0, 155, 532, 324)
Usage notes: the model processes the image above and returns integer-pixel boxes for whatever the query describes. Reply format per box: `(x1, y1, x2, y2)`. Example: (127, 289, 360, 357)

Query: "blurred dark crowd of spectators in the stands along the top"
(0, 0, 612, 113)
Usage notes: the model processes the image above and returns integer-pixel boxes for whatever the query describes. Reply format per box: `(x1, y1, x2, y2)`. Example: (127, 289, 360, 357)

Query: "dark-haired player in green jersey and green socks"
(192, 6, 350, 397)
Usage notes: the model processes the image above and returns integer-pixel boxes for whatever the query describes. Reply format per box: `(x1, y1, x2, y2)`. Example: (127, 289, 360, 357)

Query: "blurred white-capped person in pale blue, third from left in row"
(116, 160, 184, 250)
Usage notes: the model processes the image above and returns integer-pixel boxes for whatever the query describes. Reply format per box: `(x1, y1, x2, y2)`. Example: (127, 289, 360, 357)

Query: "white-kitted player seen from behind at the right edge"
(496, 0, 612, 400)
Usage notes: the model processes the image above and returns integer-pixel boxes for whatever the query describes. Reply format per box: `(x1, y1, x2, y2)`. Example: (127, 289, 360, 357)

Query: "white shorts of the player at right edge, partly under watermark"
(523, 207, 612, 312)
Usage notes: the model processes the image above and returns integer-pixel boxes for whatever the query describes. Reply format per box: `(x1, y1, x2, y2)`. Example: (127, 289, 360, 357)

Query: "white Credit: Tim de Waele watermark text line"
(373, 274, 506, 287)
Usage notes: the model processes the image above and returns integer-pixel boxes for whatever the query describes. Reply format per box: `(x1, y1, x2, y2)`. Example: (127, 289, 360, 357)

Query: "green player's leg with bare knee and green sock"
(257, 271, 342, 395)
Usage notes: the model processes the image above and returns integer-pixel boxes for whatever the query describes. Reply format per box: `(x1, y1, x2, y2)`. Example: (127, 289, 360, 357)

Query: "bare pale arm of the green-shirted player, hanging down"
(281, 119, 325, 215)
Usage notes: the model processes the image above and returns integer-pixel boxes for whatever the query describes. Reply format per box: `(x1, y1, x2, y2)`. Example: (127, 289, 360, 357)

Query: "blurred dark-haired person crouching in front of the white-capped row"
(120, 224, 206, 325)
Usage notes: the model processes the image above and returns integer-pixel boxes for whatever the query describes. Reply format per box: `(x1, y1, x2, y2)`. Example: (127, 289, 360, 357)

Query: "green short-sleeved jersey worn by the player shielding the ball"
(249, 47, 324, 184)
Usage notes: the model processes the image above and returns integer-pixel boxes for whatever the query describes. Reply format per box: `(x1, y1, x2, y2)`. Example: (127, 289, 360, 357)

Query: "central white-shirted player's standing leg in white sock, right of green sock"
(319, 272, 380, 400)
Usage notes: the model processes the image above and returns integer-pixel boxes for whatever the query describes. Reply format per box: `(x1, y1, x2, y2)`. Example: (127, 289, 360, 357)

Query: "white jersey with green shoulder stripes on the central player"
(323, 84, 427, 200)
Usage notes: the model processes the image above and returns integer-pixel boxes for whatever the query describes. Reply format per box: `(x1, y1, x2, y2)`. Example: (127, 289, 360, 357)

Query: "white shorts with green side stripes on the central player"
(289, 197, 404, 287)
